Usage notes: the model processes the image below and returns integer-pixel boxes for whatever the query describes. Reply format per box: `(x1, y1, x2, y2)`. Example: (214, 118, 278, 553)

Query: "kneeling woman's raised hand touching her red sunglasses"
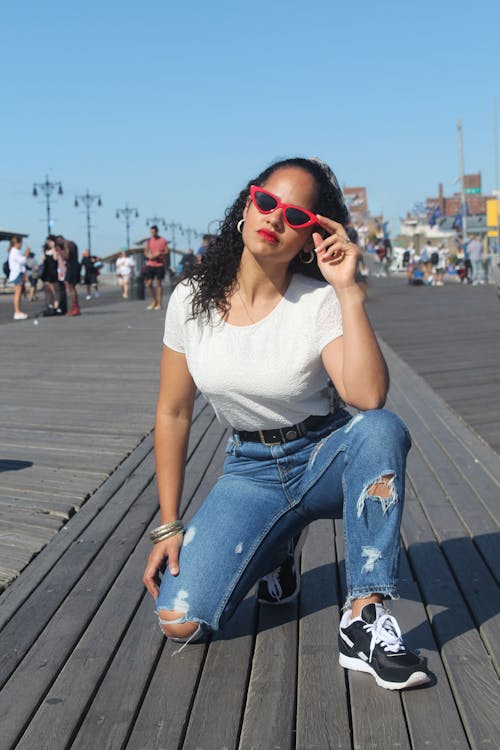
(313, 214, 361, 289)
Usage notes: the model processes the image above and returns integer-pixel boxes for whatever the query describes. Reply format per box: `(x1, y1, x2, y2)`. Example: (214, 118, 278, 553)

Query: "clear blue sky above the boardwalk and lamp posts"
(0, 0, 500, 254)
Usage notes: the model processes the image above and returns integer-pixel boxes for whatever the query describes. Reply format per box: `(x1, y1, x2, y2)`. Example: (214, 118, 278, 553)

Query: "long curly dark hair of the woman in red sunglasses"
(185, 157, 349, 318)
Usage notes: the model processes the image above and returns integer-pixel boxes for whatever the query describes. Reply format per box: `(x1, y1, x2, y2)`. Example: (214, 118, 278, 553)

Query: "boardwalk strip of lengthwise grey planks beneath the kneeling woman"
(0, 280, 500, 750)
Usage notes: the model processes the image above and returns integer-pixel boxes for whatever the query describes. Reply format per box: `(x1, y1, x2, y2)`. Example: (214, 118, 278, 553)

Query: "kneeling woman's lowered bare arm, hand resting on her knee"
(143, 346, 196, 599)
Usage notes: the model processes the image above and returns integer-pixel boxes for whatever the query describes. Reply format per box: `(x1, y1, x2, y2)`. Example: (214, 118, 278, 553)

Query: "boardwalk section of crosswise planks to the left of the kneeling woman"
(0, 290, 163, 591)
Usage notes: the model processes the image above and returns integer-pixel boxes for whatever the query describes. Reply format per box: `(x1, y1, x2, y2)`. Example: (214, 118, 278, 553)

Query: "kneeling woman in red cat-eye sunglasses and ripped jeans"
(144, 159, 429, 689)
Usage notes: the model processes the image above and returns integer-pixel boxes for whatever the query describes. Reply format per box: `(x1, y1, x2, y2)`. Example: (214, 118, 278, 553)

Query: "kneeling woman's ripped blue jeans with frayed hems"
(156, 409, 411, 640)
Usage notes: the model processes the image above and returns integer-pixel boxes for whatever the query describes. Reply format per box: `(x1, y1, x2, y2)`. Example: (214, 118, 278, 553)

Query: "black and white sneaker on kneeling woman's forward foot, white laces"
(339, 604, 431, 690)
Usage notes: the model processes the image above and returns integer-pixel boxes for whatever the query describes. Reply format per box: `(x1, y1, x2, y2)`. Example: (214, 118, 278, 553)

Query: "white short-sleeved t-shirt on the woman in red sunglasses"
(163, 273, 342, 430)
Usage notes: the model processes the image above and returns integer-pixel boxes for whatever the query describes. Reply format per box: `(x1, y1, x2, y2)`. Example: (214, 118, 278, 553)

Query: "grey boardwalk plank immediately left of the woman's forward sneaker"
(296, 521, 351, 750)
